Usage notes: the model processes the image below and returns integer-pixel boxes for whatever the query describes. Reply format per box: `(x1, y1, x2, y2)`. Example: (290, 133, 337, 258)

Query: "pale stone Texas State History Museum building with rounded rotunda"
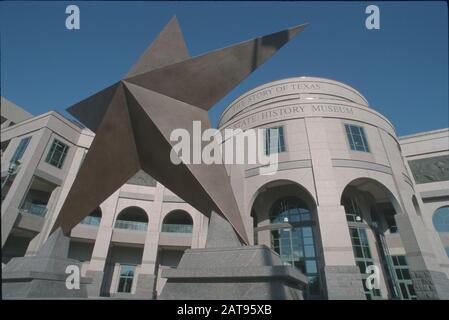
(1, 77, 449, 299)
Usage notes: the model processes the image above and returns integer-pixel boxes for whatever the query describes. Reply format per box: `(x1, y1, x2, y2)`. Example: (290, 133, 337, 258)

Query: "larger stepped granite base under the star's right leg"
(158, 245, 307, 300)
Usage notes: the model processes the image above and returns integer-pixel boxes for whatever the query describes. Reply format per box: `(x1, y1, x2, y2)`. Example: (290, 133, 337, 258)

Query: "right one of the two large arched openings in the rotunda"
(341, 178, 416, 299)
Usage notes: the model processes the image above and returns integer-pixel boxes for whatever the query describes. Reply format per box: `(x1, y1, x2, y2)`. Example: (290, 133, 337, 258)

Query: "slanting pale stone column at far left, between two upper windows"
(2, 129, 51, 247)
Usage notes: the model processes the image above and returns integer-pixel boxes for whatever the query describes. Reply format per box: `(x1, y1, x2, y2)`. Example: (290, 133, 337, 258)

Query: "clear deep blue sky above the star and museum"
(0, 1, 449, 135)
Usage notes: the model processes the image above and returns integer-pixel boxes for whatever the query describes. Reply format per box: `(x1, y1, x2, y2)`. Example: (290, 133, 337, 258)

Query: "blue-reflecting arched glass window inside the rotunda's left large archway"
(270, 197, 320, 296)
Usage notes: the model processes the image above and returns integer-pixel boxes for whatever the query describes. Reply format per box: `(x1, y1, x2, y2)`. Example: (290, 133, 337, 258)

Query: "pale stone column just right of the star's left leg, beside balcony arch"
(86, 190, 119, 297)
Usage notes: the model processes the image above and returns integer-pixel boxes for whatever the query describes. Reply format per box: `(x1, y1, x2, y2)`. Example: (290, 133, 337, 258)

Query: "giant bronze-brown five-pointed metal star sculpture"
(53, 17, 305, 244)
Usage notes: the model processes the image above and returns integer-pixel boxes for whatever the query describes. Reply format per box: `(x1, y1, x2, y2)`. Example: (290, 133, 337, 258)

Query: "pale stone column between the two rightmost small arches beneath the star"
(135, 183, 164, 299)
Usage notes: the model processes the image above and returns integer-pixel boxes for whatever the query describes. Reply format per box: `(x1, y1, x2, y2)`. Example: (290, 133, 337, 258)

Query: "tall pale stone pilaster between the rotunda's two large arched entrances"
(305, 118, 365, 299)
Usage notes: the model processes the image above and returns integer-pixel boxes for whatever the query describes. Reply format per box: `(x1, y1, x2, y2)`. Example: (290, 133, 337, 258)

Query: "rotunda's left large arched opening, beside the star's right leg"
(251, 180, 323, 299)
